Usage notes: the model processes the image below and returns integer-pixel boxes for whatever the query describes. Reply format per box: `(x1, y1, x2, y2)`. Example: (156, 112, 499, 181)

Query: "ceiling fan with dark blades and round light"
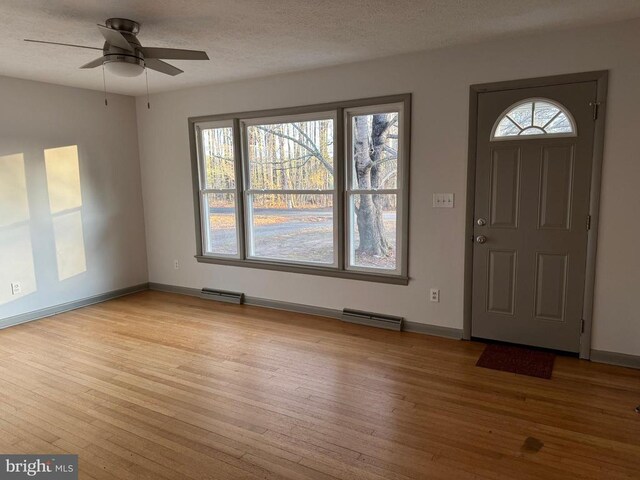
(25, 18, 209, 77)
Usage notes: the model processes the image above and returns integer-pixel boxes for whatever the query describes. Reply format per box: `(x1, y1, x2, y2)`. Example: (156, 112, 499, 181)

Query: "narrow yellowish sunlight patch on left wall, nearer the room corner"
(44, 145, 87, 281)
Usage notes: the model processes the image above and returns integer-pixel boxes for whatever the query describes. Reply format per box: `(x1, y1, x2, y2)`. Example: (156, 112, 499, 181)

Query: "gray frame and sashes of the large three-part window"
(188, 93, 411, 285)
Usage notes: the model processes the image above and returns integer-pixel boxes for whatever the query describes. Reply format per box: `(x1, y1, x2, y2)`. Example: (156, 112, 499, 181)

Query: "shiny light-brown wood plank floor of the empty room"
(0, 292, 640, 480)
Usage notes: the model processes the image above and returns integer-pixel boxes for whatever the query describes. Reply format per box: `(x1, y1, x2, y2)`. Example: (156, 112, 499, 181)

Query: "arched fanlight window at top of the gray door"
(491, 98, 576, 140)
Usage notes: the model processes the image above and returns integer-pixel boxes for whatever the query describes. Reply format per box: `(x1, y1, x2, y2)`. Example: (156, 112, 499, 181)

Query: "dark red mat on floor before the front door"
(476, 344, 556, 378)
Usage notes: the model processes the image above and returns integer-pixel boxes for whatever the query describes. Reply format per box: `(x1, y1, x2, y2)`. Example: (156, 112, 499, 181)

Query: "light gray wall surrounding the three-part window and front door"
(137, 17, 640, 355)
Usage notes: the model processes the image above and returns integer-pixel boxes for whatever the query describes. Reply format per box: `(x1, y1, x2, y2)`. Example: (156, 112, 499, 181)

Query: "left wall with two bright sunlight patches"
(0, 77, 147, 319)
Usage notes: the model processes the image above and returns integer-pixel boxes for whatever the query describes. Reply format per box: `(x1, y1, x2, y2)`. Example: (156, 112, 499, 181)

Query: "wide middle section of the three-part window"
(242, 113, 338, 266)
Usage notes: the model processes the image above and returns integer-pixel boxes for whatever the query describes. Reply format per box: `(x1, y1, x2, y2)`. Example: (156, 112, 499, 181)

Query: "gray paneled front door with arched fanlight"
(471, 81, 596, 352)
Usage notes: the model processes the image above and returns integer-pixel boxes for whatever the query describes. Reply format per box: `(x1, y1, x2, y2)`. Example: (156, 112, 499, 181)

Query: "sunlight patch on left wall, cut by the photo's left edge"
(0, 153, 37, 305)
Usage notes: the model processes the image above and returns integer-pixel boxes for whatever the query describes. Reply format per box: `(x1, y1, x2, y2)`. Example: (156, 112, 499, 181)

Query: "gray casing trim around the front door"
(462, 70, 609, 359)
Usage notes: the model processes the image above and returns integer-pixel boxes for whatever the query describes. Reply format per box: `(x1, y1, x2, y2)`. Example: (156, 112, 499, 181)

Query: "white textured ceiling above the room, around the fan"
(0, 0, 640, 95)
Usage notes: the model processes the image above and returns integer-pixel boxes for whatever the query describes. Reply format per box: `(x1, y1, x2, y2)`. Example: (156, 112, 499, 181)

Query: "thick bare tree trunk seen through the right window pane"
(354, 114, 390, 257)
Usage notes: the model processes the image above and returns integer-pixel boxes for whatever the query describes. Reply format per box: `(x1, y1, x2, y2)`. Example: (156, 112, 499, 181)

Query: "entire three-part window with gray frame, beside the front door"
(189, 95, 410, 284)
